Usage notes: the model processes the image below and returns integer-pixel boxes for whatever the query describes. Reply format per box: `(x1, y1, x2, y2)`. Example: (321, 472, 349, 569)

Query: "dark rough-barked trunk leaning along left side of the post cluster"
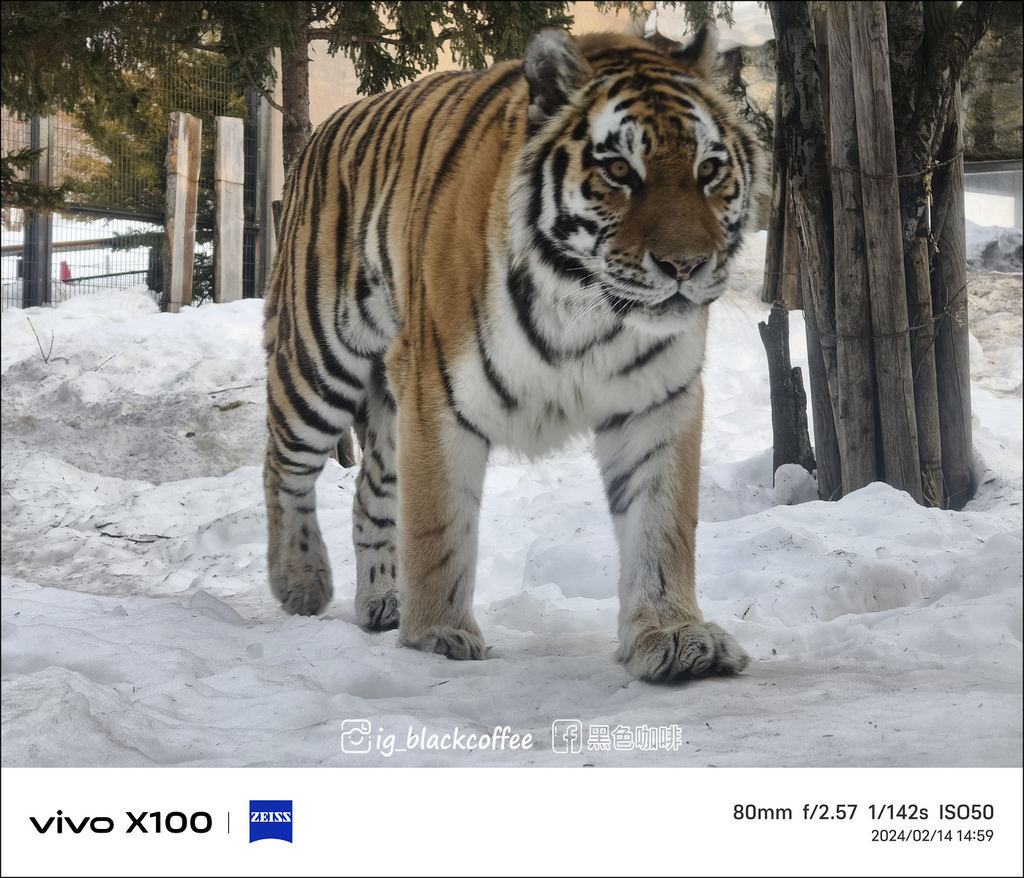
(769, 2, 843, 499)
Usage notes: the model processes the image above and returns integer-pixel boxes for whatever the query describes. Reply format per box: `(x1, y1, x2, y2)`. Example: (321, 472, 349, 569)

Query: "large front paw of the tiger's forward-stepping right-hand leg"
(617, 622, 751, 683)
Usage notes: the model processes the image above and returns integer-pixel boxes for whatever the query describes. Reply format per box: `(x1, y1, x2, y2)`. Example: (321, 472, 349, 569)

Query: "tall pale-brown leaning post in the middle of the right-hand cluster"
(849, 0, 924, 503)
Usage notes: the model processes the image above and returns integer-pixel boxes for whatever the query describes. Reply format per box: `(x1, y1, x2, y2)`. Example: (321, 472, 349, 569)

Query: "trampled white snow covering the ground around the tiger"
(2, 229, 1022, 767)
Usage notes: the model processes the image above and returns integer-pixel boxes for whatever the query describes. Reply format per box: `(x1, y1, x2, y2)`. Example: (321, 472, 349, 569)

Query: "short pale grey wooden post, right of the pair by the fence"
(213, 116, 246, 302)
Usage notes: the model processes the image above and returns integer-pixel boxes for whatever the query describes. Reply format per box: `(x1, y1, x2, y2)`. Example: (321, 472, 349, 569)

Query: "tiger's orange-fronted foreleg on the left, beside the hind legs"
(389, 340, 489, 659)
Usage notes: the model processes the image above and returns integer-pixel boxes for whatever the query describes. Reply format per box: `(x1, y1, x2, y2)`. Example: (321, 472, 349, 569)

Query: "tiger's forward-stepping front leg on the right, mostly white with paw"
(595, 378, 750, 682)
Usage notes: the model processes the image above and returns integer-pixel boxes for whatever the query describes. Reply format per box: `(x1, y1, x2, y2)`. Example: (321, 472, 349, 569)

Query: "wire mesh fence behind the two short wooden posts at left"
(0, 51, 265, 309)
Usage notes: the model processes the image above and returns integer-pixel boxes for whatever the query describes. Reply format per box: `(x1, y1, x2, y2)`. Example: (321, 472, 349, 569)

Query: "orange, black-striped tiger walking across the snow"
(263, 27, 763, 682)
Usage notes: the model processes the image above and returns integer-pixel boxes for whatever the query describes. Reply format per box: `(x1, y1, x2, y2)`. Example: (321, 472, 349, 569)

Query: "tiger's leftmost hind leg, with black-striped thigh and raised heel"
(263, 341, 370, 616)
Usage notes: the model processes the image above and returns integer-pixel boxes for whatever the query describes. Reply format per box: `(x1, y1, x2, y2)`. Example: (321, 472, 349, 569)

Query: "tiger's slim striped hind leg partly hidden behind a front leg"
(352, 361, 398, 631)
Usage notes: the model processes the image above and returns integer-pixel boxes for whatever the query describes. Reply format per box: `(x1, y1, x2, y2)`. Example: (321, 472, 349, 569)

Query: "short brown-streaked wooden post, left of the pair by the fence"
(163, 112, 203, 313)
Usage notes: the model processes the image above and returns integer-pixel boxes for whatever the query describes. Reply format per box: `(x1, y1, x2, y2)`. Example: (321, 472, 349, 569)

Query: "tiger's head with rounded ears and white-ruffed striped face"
(510, 27, 762, 334)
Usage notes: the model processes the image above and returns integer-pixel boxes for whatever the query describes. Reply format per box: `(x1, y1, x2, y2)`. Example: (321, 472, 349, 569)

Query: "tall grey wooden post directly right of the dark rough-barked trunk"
(827, 3, 879, 493)
